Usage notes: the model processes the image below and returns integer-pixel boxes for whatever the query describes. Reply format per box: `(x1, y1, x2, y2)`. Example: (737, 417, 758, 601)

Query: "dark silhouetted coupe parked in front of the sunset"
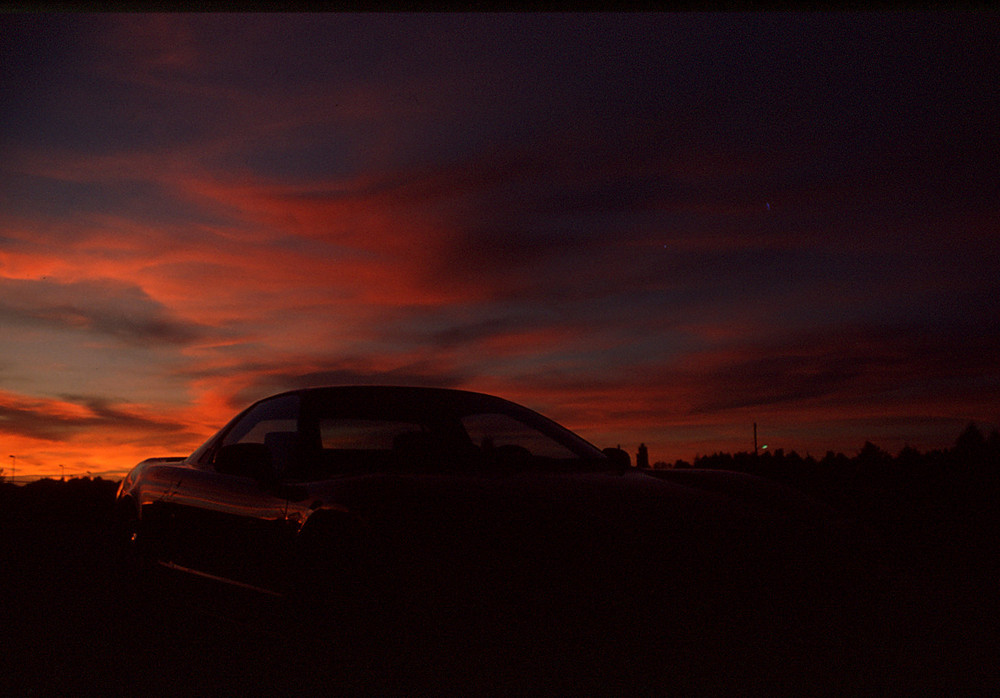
(116, 386, 888, 688)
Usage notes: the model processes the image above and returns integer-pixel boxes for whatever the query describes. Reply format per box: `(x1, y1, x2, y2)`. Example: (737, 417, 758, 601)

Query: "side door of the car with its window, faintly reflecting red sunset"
(167, 394, 299, 588)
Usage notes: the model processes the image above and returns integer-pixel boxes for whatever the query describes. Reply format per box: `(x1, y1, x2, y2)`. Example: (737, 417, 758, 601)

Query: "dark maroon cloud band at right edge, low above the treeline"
(688, 319, 1000, 413)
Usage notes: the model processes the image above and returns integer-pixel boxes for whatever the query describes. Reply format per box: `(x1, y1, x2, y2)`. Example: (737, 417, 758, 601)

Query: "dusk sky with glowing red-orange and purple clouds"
(0, 12, 1000, 480)
